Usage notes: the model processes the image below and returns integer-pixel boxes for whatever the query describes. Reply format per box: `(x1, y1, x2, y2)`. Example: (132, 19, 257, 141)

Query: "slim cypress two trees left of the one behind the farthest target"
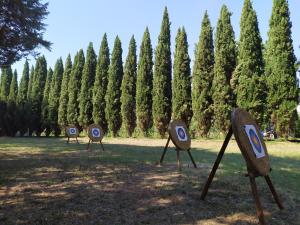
(48, 58, 64, 137)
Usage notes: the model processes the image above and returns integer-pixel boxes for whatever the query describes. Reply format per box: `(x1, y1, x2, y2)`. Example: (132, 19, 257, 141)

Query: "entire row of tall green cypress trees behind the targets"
(0, 0, 298, 137)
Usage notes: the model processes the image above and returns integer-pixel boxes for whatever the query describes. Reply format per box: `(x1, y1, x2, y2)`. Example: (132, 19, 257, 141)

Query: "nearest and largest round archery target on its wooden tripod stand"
(201, 108, 283, 225)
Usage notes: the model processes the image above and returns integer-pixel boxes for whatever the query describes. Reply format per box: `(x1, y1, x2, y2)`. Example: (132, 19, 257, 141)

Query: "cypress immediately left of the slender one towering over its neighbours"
(136, 27, 153, 136)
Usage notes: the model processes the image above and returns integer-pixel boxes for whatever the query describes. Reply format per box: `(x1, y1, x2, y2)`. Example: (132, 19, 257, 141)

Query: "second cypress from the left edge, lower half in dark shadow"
(5, 70, 18, 136)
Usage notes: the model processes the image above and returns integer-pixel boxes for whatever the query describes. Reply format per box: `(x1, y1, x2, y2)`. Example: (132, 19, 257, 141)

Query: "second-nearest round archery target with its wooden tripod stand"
(159, 120, 197, 169)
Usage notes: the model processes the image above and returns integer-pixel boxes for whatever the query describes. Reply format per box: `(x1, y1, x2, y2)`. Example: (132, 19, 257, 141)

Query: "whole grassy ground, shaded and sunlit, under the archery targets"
(0, 138, 300, 225)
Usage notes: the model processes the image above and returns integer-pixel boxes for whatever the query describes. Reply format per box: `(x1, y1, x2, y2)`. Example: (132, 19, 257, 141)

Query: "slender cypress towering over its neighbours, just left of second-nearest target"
(153, 7, 172, 137)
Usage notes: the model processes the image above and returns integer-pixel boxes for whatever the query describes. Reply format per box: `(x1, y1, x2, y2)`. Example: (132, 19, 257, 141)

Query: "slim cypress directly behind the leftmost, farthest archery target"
(67, 49, 85, 125)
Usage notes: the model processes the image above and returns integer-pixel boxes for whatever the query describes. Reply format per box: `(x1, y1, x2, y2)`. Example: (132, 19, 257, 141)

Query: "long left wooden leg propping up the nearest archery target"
(201, 127, 232, 200)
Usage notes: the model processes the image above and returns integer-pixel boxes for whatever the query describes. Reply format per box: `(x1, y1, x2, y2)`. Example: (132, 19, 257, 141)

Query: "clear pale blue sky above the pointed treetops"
(13, 0, 300, 76)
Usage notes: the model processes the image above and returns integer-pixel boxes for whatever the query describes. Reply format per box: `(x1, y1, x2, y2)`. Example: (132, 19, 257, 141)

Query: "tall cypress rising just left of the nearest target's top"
(212, 5, 236, 132)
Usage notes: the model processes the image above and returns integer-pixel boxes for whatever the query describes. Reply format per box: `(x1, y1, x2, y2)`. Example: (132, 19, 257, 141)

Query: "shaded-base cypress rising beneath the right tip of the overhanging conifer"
(30, 56, 47, 136)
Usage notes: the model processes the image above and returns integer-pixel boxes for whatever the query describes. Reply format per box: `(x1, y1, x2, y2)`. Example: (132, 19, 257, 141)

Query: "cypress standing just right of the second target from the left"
(105, 36, 123, 136)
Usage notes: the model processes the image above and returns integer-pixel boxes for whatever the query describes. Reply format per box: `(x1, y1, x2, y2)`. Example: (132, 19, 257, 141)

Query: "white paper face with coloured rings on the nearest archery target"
(245, 125, 266, 158)
